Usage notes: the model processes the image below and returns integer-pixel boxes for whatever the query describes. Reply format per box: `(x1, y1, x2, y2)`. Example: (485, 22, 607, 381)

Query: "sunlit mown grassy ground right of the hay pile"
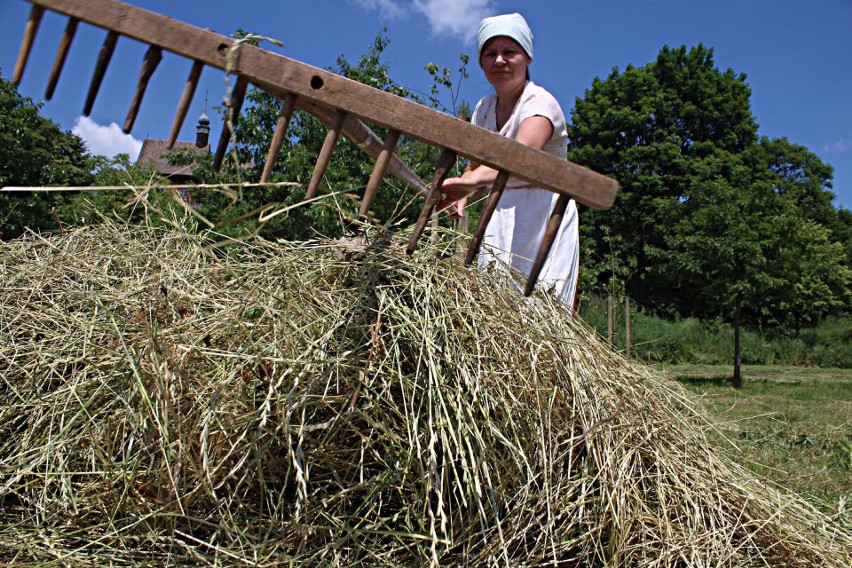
(663, 365, 852, 523)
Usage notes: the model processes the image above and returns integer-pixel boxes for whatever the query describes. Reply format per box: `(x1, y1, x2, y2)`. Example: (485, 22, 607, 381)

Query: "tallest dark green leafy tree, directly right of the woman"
(568, 45, 757, 315)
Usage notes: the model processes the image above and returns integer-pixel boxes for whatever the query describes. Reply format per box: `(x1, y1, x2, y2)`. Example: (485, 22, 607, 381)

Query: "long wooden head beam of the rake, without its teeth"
(25, 0, 618, 209)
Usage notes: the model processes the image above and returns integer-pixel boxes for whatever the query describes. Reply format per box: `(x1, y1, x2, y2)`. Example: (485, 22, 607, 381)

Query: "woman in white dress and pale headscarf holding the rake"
(440, 14, 580, 308)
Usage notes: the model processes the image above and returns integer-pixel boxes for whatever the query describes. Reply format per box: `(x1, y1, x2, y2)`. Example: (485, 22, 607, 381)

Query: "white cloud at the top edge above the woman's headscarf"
(351, 0, 496, 42)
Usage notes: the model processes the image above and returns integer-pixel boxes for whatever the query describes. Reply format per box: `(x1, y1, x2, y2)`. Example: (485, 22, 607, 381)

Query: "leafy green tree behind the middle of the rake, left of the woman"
(206, 29, 470, 239)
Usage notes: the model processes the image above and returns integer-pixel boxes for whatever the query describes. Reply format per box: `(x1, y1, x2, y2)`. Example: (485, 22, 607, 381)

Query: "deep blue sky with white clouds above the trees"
(0, 0, 852, 209)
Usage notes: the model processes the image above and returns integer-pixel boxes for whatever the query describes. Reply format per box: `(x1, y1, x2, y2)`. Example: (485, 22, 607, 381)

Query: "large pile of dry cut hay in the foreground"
(0, 224, 852, 567)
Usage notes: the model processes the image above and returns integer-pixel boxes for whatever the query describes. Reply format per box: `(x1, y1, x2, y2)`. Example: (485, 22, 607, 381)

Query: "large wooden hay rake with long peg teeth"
(12, 0, 618, 295)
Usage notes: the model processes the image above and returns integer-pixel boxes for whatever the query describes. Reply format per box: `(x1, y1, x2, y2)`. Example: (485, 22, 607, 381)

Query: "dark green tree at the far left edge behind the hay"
(0, 71, 94, 239)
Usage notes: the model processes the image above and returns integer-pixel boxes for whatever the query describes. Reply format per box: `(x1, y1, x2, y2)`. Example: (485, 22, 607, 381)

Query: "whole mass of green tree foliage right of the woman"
(569, 45, 850, 340)
